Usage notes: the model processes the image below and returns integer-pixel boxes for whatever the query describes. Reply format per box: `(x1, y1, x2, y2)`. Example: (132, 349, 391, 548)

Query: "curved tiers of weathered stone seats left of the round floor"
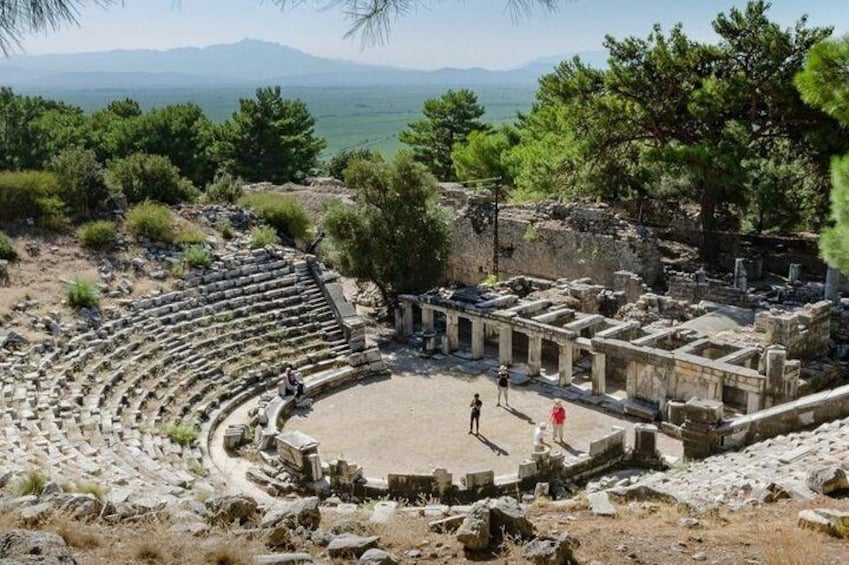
(0, 249, 350, 494)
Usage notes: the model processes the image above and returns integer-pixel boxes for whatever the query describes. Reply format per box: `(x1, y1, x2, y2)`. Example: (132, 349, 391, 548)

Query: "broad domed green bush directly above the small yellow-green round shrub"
(109, 153, 198, 204)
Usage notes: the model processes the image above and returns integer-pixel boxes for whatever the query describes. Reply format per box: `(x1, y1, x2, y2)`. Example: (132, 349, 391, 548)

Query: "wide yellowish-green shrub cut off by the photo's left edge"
(0, 171, 67, 229)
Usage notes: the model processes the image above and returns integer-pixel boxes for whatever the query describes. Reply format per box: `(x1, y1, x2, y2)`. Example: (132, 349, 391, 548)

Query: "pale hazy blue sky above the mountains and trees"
(14, 0, 849, 69)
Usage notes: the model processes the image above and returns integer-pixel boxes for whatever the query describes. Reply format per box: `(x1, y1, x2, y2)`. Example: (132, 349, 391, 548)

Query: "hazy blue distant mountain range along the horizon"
(0, 39, 606, 90)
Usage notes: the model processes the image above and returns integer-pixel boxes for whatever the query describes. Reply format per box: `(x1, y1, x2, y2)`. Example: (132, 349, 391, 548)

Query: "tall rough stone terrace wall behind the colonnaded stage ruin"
(448, 202, 663, 287)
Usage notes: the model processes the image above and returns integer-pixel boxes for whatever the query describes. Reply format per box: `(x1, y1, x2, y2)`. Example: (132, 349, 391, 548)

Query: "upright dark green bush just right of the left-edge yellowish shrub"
(49, 147, 110, 217)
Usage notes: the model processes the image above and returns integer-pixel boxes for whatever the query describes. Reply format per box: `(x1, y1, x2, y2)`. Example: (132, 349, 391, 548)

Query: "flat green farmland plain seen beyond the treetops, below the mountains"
(22, 85, 535, 157)
